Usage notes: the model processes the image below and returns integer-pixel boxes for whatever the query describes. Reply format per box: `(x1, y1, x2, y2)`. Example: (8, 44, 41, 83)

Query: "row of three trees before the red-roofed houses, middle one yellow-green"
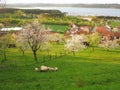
(65, 32, 120, 55)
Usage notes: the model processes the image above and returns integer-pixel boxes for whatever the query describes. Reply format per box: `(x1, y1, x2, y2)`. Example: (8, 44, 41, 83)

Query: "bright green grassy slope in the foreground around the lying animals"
(0, 45, 120, 90)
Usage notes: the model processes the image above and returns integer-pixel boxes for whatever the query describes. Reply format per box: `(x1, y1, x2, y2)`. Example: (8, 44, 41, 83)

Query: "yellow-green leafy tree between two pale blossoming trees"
(88, 32, 101, 50)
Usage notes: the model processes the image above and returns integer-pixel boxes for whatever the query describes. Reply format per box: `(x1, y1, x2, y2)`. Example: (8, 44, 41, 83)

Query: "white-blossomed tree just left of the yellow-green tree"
(65, 35, 85, 55)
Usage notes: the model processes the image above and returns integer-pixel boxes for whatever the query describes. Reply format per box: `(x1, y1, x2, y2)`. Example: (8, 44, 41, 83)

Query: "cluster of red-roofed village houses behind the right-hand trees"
(65, 24, 120, 40)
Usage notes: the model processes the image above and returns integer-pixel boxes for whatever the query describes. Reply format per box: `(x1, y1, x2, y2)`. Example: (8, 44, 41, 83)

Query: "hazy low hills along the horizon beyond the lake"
(6, 3, 120, 9)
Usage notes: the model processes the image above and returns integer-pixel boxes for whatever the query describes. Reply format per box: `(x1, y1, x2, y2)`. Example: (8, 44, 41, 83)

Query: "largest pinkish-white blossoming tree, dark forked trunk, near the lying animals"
(17, 20, 47, 63)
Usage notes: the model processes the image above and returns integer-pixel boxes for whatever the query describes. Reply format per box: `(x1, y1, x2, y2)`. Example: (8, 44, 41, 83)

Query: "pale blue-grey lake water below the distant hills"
(15, 7, 120, 17)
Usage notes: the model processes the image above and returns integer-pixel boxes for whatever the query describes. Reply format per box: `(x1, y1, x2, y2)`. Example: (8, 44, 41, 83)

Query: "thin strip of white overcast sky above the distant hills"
(3, 0, 120, 4)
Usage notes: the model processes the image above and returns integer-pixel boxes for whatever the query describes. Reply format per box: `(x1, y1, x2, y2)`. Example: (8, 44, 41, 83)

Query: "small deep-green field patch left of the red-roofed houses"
(45, 24, 68, 33)
